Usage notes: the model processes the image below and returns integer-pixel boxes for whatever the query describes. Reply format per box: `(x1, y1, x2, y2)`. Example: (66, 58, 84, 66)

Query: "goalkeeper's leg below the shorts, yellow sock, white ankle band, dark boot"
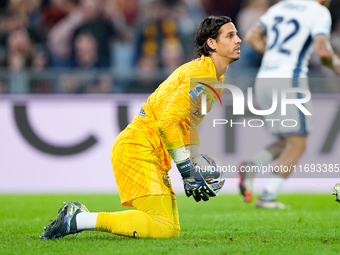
(41, 195, 175, 239)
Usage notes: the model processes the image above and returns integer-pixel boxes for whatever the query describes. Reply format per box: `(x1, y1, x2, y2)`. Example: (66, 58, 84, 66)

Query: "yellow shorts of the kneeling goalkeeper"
(111, 127, 172, 206)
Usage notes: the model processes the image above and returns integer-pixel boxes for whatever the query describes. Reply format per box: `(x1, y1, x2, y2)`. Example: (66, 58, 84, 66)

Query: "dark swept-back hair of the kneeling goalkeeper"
(195, 16, 231, 57)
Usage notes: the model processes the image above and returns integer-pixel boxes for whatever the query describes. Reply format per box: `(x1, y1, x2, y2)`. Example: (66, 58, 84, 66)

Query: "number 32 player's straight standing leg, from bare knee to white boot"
(257, 136, 307, 208)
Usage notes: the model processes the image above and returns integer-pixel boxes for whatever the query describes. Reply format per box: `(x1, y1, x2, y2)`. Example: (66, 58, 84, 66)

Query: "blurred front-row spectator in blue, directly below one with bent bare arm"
(60, 33, 113, 93)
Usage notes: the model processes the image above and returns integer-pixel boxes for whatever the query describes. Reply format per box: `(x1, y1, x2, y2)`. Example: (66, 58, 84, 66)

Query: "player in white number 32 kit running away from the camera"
(240, 0, 340, 208)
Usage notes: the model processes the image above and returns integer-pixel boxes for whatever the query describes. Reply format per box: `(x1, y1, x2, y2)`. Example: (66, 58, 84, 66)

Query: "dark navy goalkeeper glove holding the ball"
(176, 158, 216, 202)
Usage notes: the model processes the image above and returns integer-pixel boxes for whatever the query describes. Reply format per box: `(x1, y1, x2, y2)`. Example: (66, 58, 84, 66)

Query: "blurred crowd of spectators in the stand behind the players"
(0, 0, 340, 94)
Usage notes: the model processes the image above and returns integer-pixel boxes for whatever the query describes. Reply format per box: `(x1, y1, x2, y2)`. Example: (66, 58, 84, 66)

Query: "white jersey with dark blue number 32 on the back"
(258, 0, 332, 78)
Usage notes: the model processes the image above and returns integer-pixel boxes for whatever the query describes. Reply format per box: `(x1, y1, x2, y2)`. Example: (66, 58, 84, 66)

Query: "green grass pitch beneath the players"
(0, 194, 340, 255)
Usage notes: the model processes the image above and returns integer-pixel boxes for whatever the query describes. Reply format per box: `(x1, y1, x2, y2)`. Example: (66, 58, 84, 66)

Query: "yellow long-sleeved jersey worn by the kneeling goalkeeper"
(129, 56, 224, 155)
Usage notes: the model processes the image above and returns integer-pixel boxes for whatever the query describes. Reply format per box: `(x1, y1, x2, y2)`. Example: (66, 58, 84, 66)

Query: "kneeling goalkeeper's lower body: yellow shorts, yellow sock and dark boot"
(42, 130, 179, 239)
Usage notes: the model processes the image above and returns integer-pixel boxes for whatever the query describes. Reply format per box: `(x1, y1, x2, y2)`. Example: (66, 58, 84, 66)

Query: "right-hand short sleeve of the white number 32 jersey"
(311, 6, 332, 38)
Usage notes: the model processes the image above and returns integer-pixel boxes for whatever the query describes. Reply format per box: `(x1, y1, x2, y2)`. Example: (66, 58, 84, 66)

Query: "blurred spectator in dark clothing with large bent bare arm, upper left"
(47, 0, 127, 67)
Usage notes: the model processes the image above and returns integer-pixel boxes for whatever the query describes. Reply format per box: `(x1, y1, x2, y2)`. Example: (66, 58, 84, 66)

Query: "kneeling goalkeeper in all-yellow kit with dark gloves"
(40, 16, 241, 239)
